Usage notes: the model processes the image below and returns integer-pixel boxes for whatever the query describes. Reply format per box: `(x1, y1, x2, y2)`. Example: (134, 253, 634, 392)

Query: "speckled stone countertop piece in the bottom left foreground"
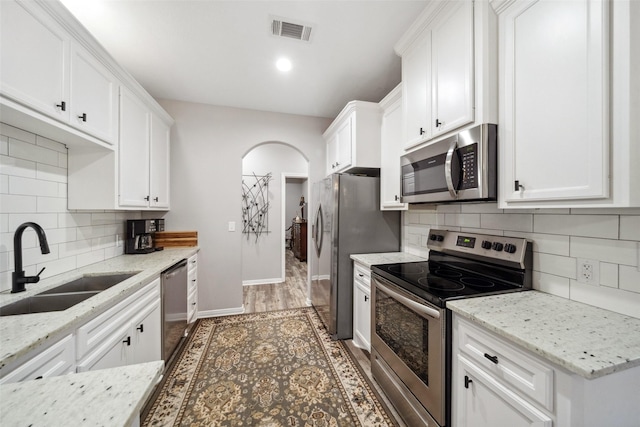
(0, 361, 164, 427)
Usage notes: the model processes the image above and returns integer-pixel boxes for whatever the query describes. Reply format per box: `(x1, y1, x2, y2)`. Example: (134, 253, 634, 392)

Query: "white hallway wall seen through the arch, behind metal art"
(238, 143, 309, 284)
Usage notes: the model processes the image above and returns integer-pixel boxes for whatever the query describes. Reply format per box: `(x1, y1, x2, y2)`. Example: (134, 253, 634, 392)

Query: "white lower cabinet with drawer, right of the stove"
(451, 313, 640, 427)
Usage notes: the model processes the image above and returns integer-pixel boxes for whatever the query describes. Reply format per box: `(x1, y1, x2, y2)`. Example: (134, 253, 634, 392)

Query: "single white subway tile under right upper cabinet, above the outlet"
(534, 215, 618, 239)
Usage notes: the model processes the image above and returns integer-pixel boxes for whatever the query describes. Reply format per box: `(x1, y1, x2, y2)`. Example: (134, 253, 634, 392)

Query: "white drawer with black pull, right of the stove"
(457, 319, 554, 411)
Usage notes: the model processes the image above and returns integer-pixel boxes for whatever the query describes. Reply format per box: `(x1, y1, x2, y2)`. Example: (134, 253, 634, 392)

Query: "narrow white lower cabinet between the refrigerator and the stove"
(353, 262, 371, 352)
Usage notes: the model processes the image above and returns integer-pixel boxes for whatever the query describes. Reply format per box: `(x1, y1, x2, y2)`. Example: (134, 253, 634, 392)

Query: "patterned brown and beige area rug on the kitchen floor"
(143, 308, 396, 427)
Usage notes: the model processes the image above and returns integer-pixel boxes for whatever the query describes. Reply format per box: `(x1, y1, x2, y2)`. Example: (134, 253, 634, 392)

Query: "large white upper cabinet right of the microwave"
(493, 0, 640, 208)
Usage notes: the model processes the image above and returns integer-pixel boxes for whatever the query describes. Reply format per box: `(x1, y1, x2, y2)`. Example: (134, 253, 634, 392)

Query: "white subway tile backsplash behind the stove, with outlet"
(403, 203, 640, 318)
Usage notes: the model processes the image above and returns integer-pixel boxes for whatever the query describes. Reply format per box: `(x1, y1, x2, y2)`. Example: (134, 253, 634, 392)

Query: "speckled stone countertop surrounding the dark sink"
(0, 247, 198, 371)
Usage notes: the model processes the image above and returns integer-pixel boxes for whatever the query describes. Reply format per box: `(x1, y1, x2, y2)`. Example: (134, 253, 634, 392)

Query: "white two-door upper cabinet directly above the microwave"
(395, 0, 497, 149)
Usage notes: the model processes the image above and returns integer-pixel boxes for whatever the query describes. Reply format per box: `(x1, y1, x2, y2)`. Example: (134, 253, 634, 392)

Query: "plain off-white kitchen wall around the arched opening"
(159, 100, 331, 315)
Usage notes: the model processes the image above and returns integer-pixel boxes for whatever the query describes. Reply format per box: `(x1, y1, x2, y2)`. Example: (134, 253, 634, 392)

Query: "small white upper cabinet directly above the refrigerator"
(323, 101, 381, 175)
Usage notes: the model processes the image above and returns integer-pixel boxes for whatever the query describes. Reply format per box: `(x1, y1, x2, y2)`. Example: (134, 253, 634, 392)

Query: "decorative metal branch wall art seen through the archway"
(242, 172, 273, 242)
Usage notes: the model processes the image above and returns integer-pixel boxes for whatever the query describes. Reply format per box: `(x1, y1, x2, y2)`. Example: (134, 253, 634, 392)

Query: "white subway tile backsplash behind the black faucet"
(0, 123, 140, 291)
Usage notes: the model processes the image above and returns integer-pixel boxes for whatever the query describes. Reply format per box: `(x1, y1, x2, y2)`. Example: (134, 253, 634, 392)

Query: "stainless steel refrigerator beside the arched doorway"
(310, 174, 400, 339)
